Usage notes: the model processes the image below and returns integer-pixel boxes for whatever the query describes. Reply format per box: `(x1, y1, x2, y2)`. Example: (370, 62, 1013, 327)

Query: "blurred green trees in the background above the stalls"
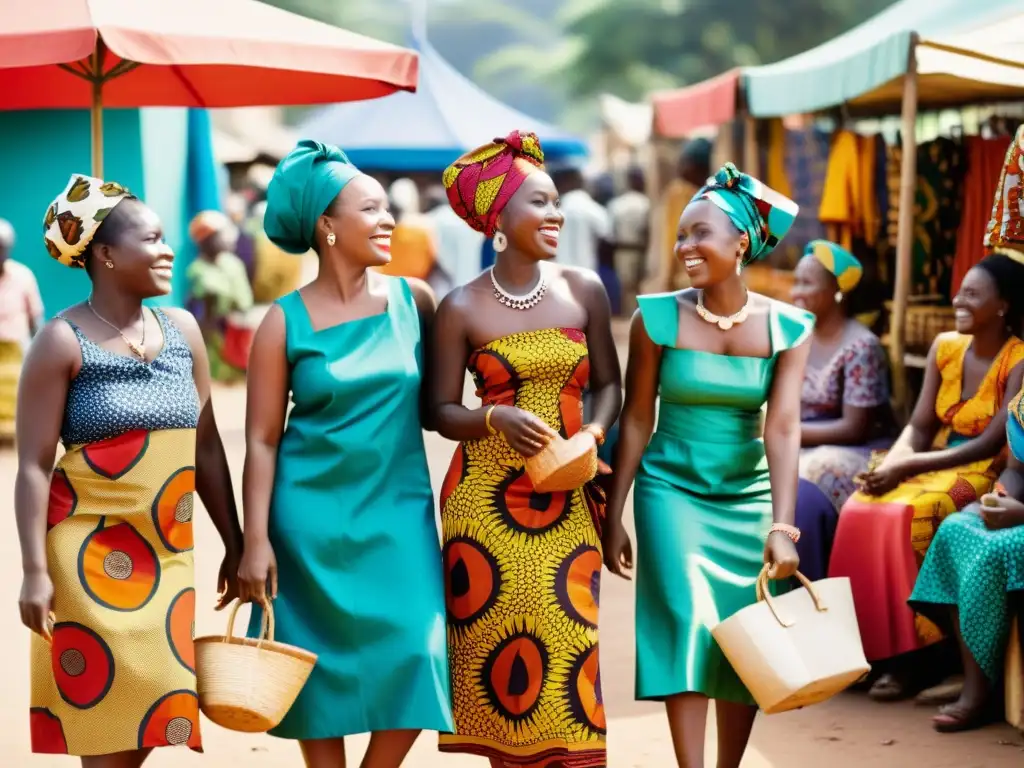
(253, 0, 895, 128)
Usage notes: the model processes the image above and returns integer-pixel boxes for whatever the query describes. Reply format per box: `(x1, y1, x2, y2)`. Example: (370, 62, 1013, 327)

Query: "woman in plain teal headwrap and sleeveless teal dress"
(240, 140, 452, 768)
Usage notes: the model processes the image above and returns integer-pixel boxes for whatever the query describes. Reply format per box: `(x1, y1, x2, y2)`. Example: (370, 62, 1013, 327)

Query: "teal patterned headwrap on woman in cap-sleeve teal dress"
(690, 163, 800, 264)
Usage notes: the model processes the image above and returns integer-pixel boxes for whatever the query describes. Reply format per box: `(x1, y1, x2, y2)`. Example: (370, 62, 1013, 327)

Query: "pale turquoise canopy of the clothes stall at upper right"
(742, 0, 1024, 118)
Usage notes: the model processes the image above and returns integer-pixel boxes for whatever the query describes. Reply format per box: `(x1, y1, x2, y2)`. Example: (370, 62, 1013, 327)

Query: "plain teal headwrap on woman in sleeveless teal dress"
(263, 138, 359, 254)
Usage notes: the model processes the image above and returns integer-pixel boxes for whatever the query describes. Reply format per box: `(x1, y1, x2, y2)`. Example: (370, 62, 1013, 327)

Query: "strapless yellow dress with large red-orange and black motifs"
(440, 329, 606, 768)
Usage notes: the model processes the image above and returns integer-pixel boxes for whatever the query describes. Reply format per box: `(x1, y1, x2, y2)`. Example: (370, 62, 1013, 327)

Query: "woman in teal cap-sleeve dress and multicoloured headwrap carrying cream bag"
(604, 163, 814, 768)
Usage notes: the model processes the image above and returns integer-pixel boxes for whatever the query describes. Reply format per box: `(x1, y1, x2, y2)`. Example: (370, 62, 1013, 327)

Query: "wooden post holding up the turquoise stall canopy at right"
(889, 34, 919, 416)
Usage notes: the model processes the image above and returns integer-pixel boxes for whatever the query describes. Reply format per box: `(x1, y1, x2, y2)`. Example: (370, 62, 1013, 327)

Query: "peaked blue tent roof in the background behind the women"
(298, 41, 588, 173)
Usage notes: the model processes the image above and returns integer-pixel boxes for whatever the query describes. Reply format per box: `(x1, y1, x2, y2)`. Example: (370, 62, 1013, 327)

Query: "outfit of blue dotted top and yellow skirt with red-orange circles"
(30, 310, 201, 756)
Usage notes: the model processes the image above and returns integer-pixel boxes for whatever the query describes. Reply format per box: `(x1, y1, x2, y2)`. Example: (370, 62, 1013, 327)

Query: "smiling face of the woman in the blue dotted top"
(89, 199, 174, 298)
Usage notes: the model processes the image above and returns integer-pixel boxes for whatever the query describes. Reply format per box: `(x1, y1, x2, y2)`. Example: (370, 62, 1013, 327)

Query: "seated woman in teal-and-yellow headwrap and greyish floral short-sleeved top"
(792, 240, 892, 581)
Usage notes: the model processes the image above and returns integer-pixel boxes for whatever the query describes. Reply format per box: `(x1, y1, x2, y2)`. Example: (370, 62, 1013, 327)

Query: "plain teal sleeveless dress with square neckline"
(249, 278, 452, 740)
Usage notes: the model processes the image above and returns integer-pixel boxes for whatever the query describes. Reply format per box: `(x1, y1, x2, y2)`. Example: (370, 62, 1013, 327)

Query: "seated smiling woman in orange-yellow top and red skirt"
(828, 254, 1024, 700)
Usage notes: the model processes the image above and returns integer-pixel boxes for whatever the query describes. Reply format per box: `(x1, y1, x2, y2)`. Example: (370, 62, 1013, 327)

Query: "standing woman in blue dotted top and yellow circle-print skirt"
(14, 175, 242, 768)
